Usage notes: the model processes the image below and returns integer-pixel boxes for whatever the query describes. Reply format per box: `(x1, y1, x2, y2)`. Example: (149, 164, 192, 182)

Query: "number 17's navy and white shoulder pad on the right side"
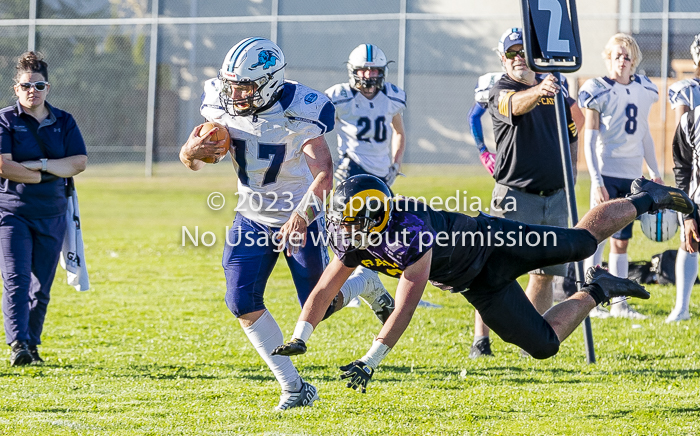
(279, 81, 335, 134)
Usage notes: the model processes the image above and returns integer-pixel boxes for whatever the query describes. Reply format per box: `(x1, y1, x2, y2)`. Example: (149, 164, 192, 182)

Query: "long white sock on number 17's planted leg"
(243, 310, 301, 392)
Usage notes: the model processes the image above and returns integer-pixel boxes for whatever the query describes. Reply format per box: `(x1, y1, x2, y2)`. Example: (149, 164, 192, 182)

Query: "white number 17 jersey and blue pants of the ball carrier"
(200, 79, 335, 317)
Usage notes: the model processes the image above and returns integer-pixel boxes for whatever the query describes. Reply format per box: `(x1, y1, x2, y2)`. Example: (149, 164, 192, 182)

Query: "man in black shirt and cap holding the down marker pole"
(482, 28, 578, 358)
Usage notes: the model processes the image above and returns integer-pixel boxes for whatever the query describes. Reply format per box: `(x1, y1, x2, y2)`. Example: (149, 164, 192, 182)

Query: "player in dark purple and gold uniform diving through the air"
(273, 175, 695, 392)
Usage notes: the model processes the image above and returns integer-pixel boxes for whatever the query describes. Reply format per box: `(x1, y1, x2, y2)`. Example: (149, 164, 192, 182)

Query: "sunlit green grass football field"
(0, 164, 700, 435)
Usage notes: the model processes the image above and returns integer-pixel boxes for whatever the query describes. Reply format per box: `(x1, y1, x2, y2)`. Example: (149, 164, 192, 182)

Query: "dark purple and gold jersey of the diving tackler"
(330, 197, 492, 292)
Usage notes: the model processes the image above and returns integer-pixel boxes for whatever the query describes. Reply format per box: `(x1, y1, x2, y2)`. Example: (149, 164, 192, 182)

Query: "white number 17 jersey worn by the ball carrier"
(200, 79, 335, 227)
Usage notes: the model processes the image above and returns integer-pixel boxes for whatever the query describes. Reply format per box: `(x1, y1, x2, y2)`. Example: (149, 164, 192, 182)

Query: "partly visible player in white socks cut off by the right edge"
(666, 33, 700, 323)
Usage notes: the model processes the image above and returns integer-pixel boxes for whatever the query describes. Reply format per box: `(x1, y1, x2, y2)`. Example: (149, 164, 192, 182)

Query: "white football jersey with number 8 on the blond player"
(578, 75, 659, 179)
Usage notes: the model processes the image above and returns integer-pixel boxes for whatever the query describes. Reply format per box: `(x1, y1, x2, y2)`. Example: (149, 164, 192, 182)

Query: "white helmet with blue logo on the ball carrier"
(219, 37, 287, 116)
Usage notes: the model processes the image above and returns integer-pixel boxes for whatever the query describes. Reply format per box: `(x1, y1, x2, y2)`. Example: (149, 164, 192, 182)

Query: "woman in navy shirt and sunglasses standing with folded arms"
(0, 52, 87, 366)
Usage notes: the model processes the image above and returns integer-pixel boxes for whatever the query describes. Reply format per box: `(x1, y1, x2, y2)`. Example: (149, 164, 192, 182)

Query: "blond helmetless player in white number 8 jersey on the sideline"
(578, 33, 663, 319)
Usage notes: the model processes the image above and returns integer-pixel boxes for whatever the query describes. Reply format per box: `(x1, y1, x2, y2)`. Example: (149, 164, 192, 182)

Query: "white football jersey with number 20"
(326, 82, 406, 177)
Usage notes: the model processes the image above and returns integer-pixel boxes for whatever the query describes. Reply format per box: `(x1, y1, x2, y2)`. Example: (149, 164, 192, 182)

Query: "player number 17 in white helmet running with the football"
(180, 38, 393, 410)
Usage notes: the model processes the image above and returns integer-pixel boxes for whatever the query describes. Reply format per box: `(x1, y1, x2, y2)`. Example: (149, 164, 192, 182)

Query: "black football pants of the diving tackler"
(462, 217, 598, 359)
